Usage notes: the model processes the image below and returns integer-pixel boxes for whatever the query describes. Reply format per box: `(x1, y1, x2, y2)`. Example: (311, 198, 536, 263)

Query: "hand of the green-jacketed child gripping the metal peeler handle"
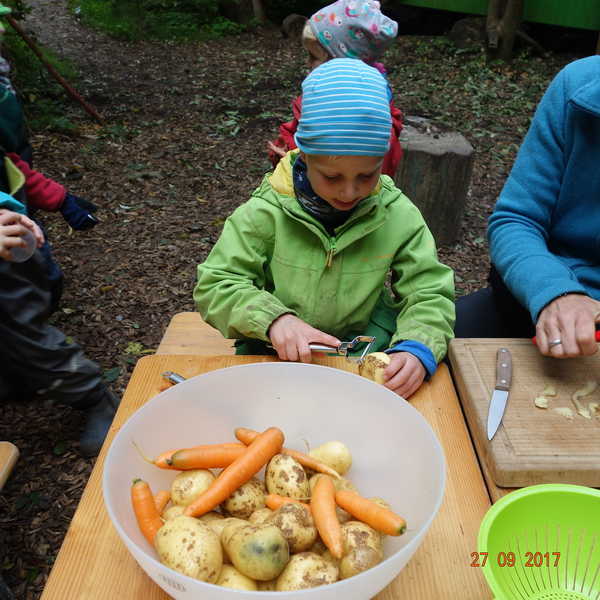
(269, 314, 341, 362)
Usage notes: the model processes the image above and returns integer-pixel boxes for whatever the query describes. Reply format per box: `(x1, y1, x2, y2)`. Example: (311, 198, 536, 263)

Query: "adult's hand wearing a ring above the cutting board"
(536, 294, 600, 358)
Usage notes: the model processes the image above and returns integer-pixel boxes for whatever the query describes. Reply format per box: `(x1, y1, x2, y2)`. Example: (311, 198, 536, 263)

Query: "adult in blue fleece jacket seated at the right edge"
(456, 56, 600, 358)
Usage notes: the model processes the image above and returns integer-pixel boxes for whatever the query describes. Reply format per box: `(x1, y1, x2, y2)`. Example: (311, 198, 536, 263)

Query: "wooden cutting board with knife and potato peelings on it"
(449, 338, 600, 487)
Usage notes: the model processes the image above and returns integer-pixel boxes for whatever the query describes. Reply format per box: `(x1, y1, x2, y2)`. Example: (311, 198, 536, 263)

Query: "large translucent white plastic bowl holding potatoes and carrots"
(103, 363, 446, 600)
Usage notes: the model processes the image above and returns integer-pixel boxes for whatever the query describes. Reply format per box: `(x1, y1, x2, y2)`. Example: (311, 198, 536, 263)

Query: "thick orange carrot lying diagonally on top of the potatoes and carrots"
(183, 427, 284, 517)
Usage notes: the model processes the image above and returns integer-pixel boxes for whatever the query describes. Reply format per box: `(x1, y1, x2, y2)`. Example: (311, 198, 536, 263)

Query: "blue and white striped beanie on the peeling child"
(294, 58, 392, 156)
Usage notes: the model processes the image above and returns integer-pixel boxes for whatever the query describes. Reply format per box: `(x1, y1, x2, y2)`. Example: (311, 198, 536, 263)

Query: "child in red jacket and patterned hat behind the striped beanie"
(267, 0, 402, 178)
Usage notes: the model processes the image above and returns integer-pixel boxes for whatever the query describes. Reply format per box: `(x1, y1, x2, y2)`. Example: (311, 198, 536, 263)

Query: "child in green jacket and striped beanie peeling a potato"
(194, 58, 454, 398)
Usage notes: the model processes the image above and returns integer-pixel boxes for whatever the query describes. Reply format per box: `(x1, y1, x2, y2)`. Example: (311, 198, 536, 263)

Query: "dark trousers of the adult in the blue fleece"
(454, 265, 535, 338)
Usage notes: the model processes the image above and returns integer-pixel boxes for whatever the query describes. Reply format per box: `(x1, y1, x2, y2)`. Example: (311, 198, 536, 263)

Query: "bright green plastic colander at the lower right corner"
(477, 484, 600, 600)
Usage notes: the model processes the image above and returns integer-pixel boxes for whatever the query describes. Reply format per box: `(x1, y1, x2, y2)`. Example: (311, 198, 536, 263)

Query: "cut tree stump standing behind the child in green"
(395, 116, 473, 246)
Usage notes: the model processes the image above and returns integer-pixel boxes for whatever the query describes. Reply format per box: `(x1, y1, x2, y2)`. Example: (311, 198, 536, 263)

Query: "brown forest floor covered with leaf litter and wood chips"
(0, 0, 592, 600)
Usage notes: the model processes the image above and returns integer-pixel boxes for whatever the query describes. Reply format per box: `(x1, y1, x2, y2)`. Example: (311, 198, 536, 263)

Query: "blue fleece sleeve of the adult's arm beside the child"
(488, 62, 585, 322)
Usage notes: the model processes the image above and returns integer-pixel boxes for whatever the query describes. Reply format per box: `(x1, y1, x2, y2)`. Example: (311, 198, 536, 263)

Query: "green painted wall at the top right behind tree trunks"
(394, 0, 600, 30)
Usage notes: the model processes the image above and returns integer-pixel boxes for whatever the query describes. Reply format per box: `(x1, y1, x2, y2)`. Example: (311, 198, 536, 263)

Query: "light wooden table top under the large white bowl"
(41, 354, 491, 600)
